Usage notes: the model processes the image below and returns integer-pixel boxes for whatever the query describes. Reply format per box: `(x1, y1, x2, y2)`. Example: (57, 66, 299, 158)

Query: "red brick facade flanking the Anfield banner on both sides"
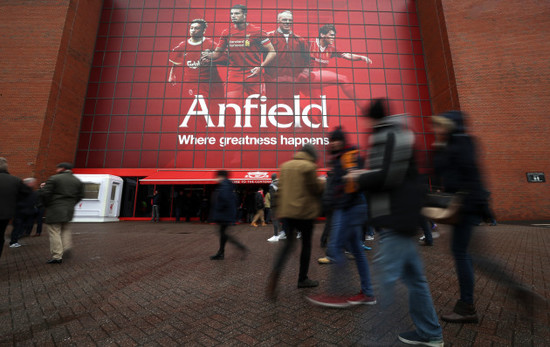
(0, 0, 550, 220)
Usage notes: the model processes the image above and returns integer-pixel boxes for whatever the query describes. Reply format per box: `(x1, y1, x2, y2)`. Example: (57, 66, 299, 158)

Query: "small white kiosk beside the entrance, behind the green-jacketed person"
(73, 174, 123, 222)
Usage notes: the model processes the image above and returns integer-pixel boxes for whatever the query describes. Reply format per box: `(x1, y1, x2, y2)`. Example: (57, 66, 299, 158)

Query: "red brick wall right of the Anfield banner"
(417, 0, 550, 220)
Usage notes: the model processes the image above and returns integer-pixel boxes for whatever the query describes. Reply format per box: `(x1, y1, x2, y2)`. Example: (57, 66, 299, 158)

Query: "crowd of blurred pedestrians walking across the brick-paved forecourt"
(0, 99, 538, 346)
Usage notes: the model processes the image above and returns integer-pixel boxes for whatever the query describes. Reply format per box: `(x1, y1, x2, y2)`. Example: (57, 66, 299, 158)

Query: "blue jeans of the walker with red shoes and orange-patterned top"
(327, 201, 374, 296)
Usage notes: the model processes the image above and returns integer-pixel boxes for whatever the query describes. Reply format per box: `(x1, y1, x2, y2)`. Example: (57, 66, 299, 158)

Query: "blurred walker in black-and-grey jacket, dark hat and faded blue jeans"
(349, 99, 444, 346)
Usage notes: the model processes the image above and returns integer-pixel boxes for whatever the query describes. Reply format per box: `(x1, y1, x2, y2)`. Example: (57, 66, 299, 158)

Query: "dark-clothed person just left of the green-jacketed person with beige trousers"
(10, 178, 38, 248)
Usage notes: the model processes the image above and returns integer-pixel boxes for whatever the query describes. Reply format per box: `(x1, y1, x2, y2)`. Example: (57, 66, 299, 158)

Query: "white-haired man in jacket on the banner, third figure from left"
(264, 11, 310, 104)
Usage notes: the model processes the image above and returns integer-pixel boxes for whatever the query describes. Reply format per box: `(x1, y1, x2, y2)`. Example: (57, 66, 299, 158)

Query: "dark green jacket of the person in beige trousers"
(40, 170, 84, 224)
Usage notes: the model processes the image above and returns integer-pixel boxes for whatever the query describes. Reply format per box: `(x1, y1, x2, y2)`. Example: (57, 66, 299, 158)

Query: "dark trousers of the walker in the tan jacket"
(273, 218, 313, 281)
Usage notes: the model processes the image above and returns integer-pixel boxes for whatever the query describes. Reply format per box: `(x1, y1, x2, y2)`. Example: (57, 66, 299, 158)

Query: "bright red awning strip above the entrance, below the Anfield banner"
(139, 170, 274, 184)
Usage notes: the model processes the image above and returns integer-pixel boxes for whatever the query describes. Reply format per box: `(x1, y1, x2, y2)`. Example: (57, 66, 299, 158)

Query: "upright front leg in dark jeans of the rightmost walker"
(451, 214, 479, 305)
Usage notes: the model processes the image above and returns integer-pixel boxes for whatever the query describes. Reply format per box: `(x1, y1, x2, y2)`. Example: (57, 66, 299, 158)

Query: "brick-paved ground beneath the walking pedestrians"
(0, 222, 550, 346)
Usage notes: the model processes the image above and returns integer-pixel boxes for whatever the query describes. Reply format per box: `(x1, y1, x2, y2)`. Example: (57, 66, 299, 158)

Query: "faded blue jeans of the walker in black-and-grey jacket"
(376, 230, 443, 339)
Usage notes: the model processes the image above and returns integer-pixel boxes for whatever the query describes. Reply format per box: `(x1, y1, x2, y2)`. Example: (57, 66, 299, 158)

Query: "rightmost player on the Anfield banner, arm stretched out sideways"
(309, 24, 372, 109)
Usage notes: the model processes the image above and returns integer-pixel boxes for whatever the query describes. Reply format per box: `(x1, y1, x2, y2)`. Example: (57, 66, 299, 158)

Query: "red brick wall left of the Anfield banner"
(0, 0, 102, 184)
